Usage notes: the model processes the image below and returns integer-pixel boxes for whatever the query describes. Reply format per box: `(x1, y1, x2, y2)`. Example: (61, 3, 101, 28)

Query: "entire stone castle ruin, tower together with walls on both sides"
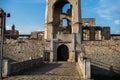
(0, 0, 120, 78)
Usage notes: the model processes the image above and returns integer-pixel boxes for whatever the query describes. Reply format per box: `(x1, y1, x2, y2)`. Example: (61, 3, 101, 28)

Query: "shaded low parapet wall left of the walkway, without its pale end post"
(8, 58, 43, 75)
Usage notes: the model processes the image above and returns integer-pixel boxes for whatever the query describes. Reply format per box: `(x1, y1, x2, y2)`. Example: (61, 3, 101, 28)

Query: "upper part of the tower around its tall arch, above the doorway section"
(45, 0, 82, 40)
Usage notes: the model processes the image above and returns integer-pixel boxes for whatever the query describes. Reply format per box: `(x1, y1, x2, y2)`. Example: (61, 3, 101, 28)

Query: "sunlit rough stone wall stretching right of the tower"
(82, 40, 120, 74)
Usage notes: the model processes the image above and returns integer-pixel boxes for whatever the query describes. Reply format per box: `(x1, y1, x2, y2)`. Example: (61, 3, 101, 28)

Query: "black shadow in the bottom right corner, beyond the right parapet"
(91, 65, 120, 80)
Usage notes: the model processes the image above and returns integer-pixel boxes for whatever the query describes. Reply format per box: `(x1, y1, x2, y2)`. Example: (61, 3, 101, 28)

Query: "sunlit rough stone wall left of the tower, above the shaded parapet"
(4, 39, 44, 62)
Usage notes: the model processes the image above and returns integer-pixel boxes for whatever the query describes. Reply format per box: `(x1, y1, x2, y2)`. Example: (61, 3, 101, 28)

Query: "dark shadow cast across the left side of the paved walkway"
(10, 63, 61, 76)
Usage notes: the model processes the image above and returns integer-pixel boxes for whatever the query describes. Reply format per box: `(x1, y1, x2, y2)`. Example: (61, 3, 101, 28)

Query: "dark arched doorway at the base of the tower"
(57, 45, 69, 61)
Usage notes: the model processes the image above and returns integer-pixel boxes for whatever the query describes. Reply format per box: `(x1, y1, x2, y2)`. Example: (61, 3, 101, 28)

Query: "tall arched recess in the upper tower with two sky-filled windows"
(53, 0, 72, 34)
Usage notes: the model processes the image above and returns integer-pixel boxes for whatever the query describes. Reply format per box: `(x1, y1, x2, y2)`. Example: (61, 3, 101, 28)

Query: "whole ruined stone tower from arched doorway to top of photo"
(44, 0, 82, 62)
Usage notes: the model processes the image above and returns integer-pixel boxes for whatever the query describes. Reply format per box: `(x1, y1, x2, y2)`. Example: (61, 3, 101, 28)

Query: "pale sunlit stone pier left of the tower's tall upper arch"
(44, 0, 53, 40)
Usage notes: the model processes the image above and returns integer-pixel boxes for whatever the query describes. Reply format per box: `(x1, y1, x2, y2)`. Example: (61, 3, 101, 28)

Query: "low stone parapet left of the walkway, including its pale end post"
(3, 58, 43, 77)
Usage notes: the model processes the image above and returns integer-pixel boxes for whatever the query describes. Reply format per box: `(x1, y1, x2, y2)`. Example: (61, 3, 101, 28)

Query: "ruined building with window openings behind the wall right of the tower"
(82, 18, 110, 41)
